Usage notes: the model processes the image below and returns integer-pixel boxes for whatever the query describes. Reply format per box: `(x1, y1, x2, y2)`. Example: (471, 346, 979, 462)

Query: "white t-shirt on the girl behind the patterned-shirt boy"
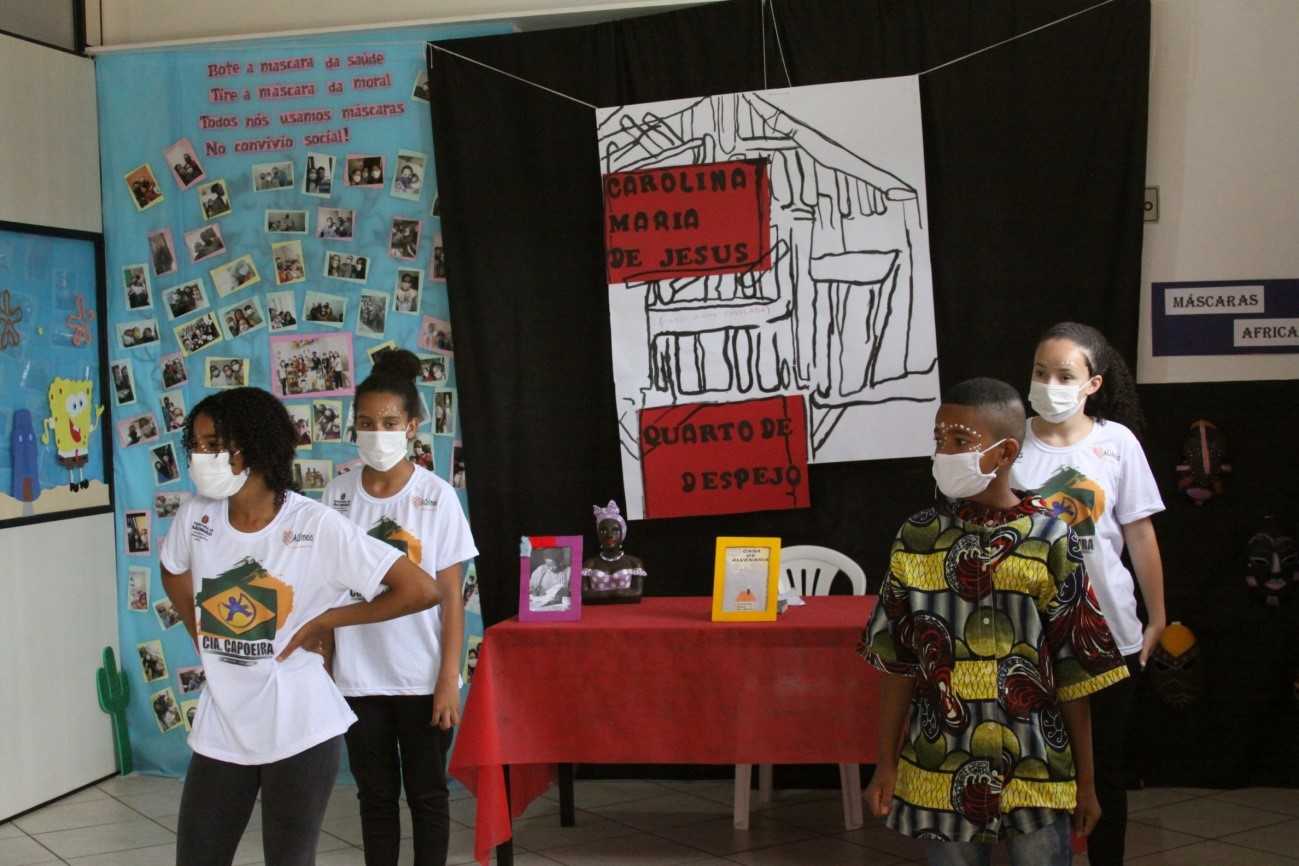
(1011, 418, 1164, 656)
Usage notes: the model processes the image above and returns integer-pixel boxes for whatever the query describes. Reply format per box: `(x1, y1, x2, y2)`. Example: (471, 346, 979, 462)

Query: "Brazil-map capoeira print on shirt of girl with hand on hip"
(195, 557, 294, 665)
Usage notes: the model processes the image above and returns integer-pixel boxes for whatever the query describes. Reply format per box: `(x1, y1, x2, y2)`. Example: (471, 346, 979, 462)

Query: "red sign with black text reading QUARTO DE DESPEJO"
(640, 395, 811, 518)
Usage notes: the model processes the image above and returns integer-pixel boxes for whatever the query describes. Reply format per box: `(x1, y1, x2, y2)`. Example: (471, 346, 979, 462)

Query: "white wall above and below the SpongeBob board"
(0, 36, 117, 821)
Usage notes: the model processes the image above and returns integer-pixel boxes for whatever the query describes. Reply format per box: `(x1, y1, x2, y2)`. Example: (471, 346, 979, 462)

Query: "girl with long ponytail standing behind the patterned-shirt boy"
(1011, 322, 1165, 866)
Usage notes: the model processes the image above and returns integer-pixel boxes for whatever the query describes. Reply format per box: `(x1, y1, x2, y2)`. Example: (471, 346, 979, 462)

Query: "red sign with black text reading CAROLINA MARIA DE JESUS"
(604, 160, 772, 286)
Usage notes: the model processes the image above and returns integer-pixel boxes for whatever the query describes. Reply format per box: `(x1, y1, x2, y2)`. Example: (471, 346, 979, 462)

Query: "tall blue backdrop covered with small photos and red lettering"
(95, 25, 508, 775)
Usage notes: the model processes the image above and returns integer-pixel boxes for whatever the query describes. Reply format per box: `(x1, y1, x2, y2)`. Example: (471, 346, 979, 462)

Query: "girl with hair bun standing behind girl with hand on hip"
(323, 349, 478, 866)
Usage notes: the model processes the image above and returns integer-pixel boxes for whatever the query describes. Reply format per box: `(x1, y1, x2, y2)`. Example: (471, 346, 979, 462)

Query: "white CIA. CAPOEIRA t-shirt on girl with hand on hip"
(160, 493, 400, 763)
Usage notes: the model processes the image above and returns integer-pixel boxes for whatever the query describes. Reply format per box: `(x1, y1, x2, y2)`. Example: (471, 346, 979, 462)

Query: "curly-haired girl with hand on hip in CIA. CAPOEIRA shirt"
(158, 388, 441, 866)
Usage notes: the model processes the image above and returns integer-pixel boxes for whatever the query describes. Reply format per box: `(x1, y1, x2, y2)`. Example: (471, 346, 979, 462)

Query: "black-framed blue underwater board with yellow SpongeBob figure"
(0, 222, 113, 527)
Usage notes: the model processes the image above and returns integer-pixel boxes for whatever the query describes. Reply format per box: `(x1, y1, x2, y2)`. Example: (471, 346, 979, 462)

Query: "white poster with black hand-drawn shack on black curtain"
(598, 78, 938, 517)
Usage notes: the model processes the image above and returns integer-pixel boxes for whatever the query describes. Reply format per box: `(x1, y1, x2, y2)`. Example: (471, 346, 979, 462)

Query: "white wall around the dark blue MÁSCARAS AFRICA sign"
(1137, 0, 1299, 383)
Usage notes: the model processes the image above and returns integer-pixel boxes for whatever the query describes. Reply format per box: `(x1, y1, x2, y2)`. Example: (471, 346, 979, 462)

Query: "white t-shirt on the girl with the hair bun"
(321, 465, 478, 697)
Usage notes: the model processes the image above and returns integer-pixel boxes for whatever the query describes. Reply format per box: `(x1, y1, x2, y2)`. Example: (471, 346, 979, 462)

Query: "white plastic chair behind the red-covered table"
(733, 544, 866, 830)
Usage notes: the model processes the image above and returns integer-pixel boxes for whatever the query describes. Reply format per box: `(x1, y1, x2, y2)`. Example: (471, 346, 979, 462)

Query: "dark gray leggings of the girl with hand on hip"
(175, 735, 343, 866)
